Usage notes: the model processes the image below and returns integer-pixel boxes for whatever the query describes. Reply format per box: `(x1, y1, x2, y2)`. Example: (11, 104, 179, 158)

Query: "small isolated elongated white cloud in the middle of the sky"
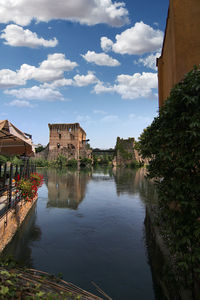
(82, 51, 120, 67)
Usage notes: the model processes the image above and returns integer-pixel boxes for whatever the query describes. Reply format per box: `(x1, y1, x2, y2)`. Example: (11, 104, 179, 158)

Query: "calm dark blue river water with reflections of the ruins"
(4, 169, 163, 300)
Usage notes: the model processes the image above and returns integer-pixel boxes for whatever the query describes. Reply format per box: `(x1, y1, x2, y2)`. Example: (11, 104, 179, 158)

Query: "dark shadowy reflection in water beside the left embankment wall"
(1, 204, 42, 268)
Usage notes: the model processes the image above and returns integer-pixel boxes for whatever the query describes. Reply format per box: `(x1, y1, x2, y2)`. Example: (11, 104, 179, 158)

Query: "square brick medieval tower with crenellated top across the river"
(48, 123, 91, 160)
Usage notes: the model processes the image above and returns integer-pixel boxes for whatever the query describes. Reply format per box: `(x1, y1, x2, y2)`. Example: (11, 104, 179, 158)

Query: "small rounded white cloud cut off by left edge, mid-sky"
(0, 69, 26, 88)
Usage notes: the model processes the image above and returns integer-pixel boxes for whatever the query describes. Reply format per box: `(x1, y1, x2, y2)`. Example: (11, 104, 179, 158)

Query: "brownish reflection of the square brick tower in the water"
(46, 169, 91, 209)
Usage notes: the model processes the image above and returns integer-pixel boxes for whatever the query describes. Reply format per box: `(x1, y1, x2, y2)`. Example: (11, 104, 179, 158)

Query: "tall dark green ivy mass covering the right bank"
(139, 68, 200, 284)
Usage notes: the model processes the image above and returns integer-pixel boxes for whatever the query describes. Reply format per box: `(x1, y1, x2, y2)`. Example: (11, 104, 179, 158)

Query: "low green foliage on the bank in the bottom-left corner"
(0, 261, 82, 300)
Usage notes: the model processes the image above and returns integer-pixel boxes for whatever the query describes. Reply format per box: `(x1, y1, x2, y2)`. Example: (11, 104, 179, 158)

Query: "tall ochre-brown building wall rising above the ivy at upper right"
(157, 0, 200, 106)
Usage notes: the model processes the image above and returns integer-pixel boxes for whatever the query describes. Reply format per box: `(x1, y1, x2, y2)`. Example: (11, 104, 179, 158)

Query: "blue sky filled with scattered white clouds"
(0, 0, 168, 149)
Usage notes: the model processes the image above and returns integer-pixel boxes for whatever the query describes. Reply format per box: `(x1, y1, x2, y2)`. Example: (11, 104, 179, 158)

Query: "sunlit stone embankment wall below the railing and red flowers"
(0, 196, 37, 253)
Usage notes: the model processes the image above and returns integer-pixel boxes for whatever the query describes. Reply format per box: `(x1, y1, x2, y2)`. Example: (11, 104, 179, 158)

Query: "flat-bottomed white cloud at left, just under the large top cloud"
(0, 24, 58, 48)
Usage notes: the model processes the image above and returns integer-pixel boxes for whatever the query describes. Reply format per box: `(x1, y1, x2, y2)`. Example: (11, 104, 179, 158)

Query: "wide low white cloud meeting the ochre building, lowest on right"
(93, 72, 158, 99)
